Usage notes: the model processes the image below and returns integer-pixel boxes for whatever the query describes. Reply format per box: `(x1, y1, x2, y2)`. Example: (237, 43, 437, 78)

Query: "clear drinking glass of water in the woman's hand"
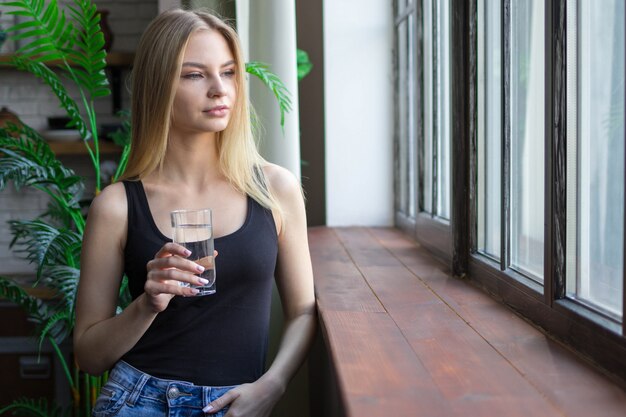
(170, 209, 216, 296)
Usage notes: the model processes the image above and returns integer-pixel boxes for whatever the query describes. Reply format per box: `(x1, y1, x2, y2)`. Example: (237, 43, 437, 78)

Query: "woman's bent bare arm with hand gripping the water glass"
(74, 183, 210, 375)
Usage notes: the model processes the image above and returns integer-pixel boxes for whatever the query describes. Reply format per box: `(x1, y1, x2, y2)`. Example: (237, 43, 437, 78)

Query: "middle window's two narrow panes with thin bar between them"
(476, 0, 545, 283)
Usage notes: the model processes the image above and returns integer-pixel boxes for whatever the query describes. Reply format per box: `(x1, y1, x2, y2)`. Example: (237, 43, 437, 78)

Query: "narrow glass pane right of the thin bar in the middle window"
(508, 0, 546, 282)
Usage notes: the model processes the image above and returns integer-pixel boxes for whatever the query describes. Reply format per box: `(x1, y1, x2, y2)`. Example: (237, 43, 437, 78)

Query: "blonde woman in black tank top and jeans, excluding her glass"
(74, 10, 315, 416)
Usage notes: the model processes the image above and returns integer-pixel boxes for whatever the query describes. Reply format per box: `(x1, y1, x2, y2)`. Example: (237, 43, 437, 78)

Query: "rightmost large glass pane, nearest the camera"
(566, 0, 626, 317)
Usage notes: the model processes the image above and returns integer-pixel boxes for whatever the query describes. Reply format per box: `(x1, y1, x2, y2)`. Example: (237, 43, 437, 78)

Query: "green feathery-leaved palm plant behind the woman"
(0, 0, 291, 416)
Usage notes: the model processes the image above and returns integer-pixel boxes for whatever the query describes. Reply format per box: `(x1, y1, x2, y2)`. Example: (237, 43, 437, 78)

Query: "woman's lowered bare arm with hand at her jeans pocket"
(204, 166, 317, 417)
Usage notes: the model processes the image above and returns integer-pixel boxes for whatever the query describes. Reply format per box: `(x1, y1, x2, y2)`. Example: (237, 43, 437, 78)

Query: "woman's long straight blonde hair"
(122, 9, 282, 217)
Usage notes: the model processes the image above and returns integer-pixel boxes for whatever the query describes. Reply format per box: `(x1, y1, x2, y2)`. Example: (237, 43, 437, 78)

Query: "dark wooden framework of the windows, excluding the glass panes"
(395, 0, 626, 381)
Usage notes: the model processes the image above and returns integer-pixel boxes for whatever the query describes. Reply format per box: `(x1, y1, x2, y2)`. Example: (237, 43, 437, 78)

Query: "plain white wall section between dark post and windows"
(324, 0, 393, 226)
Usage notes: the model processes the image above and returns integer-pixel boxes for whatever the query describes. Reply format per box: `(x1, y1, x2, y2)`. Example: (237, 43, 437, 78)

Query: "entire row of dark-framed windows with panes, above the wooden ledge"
(396, 0, 626, 379)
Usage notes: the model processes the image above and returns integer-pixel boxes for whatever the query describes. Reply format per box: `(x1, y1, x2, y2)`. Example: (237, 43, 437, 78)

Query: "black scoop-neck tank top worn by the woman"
(122, 181, 278, 386)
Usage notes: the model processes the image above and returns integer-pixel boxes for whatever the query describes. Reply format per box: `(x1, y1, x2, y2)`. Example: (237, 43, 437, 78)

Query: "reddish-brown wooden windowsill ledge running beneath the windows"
(309, 227, 626, 417)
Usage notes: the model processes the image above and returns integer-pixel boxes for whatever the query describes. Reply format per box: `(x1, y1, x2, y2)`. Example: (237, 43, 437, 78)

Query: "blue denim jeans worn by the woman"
(92, 361, 235, 417)
